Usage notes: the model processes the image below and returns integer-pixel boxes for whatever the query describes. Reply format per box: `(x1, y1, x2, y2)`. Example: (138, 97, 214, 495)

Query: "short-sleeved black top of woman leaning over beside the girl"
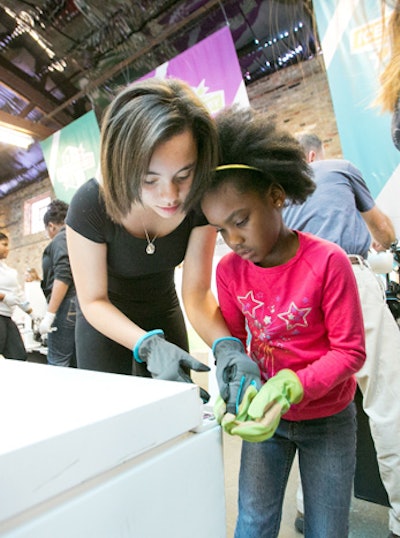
(66, 179, 207, 303)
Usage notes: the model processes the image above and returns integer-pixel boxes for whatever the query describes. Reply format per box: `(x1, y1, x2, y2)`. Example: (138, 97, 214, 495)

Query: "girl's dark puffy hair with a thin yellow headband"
(211, 106, 315, 204)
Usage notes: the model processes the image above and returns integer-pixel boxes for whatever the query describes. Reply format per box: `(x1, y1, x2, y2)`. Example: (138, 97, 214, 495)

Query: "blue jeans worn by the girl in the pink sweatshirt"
(235, 403, 356, 538)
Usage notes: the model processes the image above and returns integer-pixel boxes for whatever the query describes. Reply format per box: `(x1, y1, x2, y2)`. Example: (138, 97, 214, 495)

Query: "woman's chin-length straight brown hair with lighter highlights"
(100, 78, 217, 223)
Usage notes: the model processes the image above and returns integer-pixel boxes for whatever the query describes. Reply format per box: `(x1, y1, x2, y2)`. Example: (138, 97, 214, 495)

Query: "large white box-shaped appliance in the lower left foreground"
(0, 359, 226, 538)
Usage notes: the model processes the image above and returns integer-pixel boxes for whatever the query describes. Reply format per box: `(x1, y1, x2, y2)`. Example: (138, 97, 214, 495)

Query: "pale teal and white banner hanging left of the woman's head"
(40, 111, 100, 203)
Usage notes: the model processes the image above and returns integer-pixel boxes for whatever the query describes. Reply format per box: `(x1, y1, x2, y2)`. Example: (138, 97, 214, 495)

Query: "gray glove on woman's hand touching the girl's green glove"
(212, 336, 261, 415)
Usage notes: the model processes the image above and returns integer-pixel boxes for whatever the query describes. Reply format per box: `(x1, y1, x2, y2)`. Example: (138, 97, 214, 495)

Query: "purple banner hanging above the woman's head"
(142, 27, 249, 114)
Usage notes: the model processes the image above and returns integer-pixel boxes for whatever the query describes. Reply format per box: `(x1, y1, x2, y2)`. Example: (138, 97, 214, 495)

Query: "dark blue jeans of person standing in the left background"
(47, 296, 76, 367)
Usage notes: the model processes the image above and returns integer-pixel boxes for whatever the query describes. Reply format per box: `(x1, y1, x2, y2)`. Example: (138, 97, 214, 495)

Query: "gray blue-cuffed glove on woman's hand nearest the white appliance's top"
(133, 329, 210, 403)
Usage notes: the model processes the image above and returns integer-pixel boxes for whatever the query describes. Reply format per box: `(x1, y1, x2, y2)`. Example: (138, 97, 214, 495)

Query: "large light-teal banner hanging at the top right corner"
(314, 0, 400, 231)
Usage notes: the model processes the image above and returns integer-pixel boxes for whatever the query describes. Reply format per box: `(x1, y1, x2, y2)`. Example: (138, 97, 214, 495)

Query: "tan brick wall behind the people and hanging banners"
(0, 57, 341, 284)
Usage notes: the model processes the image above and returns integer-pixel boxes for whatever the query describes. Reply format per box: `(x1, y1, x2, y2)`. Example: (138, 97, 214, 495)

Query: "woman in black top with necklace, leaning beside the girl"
(67, 79, 259, 402)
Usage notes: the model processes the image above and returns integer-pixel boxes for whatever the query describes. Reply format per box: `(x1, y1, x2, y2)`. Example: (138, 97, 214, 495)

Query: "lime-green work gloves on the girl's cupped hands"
(229, 369, 304, 442)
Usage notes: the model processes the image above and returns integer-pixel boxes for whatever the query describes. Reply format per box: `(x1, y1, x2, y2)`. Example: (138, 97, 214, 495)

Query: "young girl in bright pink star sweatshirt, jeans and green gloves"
(201, 105, 365, 538)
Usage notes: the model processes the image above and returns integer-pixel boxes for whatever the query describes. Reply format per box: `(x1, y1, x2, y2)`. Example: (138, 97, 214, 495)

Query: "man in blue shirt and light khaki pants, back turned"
(283, 133, 400, 538)
